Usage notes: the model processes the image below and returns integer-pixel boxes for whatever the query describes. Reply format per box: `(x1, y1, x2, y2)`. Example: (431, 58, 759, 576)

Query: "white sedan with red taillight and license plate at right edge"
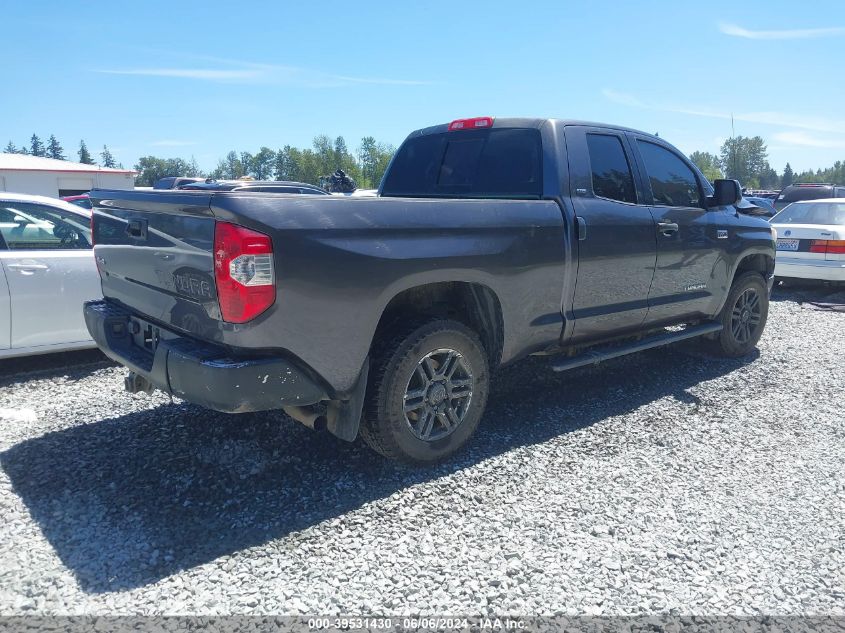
(772, 198, 845, 281)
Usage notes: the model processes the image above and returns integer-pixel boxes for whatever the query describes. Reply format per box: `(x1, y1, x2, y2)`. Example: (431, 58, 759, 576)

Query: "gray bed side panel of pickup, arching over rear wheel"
(211, 194, 565, 394)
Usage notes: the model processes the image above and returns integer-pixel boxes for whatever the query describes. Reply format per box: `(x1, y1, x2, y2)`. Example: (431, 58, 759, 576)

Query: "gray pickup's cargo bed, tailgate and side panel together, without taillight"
(91, 190, 571, 393)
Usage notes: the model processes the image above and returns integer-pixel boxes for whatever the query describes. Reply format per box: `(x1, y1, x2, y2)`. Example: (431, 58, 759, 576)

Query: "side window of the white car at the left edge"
(0, 201, 91, 251)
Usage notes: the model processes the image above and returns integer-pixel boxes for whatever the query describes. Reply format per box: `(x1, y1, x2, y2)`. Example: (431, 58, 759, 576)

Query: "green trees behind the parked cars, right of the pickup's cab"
(690, 136, 845, 189)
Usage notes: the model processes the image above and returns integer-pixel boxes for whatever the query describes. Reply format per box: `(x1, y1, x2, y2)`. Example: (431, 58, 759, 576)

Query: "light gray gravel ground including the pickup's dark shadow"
(0, 290, 845, 616)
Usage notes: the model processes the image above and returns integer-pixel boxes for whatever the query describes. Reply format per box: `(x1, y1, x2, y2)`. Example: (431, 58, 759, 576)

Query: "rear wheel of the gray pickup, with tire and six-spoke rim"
(361, 320, 490, 464)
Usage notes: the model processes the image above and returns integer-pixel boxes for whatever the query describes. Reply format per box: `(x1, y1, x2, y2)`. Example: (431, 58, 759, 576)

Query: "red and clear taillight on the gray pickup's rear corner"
(214, 222, 276, 323)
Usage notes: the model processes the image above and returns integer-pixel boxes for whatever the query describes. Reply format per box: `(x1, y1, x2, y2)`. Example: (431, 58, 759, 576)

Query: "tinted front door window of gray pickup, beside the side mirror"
(637, 139, 702, 207)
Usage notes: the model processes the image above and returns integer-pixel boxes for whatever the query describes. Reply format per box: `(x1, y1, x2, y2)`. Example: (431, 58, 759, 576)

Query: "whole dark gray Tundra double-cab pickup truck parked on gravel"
(85, 117, 775, 463)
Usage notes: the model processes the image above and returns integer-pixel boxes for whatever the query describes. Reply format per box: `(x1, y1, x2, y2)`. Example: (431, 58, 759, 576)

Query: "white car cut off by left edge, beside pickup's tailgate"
(0, 191, 102, 358)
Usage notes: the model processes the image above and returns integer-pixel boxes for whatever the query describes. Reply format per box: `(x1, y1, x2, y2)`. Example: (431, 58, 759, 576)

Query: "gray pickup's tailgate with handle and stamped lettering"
(91, 190, 220, 340)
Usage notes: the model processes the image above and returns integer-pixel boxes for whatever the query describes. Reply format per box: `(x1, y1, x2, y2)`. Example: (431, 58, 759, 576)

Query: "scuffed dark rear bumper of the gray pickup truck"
(84, 301, 327, 413)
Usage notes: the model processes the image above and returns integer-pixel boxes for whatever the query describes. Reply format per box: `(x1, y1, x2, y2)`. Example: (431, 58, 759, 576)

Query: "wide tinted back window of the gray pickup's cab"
(382, 128, 542, 198)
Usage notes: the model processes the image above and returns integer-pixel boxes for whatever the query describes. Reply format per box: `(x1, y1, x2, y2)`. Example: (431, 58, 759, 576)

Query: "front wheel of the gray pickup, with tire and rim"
(708, 272, 769, 358)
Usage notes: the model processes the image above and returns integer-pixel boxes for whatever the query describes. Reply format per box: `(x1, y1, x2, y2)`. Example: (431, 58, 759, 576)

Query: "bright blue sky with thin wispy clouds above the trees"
(0, 0, 845, 171)
